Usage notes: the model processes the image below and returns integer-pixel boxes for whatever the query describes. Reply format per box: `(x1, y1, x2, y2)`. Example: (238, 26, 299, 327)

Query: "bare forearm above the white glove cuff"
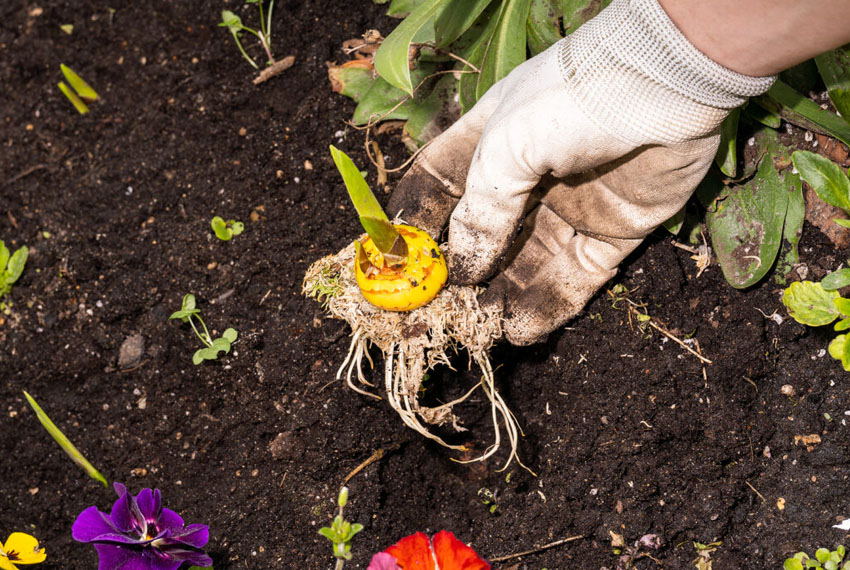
(659, 0, 850, 76)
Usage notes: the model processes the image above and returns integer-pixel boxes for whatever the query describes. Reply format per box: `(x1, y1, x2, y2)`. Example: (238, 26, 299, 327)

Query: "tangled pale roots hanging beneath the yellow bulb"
(303, 240, 527, 469)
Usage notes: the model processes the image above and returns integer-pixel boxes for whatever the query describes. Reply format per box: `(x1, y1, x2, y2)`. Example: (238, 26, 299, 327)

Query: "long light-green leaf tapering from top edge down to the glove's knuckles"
(475, 0, 531, 99)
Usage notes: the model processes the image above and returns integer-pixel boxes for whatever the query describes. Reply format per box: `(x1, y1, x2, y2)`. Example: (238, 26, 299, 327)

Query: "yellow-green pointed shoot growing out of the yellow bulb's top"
(330, 145, 403, 253)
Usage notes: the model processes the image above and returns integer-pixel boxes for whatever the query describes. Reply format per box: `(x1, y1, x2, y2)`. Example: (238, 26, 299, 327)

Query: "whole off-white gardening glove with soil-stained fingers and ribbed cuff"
(389, 0, 774, 345)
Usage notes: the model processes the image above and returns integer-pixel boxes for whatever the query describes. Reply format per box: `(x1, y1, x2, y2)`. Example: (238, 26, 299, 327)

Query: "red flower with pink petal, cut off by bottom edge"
(367, 530, 490, 570)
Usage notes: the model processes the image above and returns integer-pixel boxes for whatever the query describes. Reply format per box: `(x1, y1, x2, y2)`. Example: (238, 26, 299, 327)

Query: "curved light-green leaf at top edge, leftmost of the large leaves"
(375, 0, 448, 95)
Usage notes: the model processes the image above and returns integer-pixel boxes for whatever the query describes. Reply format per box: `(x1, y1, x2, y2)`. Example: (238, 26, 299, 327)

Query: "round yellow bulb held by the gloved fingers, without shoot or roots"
(354, 224, 449, 311)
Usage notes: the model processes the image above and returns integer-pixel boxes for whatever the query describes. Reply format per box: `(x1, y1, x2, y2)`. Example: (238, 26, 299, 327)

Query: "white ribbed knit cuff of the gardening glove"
(559, 0, 776, 144)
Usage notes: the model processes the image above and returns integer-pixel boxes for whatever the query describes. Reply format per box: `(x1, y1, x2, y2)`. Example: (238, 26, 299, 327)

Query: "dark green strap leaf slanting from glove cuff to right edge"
(754, 81, 850, 151)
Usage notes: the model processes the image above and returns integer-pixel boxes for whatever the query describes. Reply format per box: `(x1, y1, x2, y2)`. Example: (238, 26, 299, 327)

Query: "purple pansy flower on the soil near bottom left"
(71, 483, 212, 570)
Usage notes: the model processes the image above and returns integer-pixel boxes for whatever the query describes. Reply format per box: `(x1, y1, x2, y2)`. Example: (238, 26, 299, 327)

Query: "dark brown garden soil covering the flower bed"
(0, 0, 850, 570)
